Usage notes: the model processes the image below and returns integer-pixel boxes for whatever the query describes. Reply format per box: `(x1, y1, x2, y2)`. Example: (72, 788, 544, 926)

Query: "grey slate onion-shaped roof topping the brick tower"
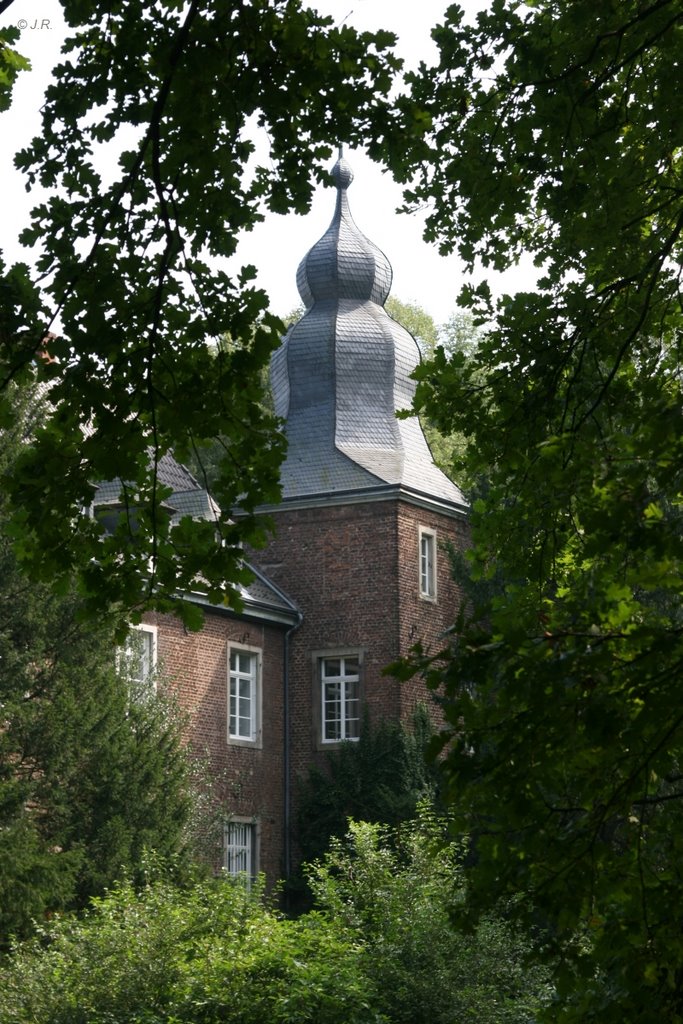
(271, 156, 466, 508)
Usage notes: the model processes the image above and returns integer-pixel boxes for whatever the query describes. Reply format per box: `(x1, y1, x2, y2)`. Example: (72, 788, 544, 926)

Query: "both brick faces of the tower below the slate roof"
(253, 500, 473, 856)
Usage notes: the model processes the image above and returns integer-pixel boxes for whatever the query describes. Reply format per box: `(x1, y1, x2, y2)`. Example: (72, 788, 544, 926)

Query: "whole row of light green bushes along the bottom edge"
(0, 818, 547, 1024)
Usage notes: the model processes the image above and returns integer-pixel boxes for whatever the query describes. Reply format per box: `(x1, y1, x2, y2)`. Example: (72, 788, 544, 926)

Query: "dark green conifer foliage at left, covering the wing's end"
(0, 388, 189, 948)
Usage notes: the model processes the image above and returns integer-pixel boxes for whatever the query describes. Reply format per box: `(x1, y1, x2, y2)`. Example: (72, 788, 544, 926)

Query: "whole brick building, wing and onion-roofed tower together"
(117, 157, 466, 880)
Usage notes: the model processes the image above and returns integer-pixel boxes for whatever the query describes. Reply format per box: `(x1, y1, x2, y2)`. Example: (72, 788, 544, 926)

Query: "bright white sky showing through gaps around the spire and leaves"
(0, 0, 524, 322)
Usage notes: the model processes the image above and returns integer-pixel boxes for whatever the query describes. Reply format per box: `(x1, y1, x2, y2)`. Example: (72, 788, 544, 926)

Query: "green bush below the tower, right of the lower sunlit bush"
(308, 809, 549, 1024)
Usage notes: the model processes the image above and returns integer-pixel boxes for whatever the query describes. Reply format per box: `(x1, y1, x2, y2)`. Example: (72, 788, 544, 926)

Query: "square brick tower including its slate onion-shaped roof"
(252, 149, 467, 872)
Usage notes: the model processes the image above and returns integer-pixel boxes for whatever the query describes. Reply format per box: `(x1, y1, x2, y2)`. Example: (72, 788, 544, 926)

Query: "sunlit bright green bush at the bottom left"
(0, 881, 383, 1024)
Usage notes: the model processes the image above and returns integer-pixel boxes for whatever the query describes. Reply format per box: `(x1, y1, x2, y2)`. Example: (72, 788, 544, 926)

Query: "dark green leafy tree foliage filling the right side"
(381, 0, 683, 1022)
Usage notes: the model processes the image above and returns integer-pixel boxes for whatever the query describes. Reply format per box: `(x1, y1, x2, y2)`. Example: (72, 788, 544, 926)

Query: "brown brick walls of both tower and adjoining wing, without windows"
(145, 500, 467, 883)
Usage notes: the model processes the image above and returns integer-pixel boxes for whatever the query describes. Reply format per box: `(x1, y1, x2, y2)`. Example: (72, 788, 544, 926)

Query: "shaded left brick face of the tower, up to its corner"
(255, 502, 399, 773)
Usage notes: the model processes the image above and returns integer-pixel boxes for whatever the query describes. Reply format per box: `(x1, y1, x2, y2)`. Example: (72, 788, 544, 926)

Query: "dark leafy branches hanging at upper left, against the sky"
(0, 0, 398, 612)
